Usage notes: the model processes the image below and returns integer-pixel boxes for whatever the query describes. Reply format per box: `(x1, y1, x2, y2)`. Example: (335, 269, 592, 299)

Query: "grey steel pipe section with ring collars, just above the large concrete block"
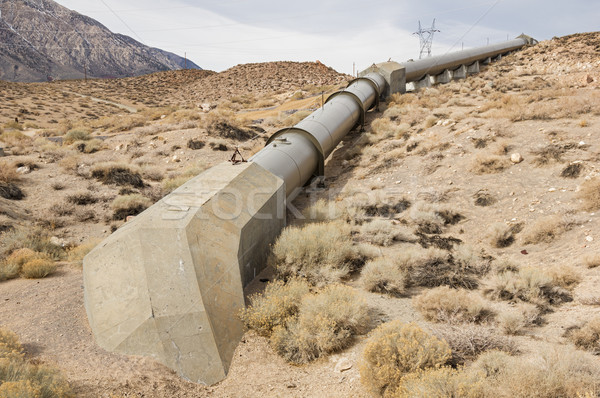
(250, 73, 386, 199)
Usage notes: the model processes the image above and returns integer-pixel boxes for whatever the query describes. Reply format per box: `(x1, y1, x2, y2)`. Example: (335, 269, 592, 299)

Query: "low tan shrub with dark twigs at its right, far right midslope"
(486, 267, 572, 306)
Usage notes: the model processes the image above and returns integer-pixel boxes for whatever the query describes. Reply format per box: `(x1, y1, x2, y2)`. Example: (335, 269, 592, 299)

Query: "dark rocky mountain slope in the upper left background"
(0, 0, 201, 82)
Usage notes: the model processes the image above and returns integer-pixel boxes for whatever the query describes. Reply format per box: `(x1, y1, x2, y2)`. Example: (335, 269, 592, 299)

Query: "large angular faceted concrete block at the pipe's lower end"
(83, 163, 285, 384)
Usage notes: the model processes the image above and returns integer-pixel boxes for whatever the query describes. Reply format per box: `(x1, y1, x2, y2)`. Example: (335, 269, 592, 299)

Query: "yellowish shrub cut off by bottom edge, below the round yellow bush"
(389, 366, 484, 398)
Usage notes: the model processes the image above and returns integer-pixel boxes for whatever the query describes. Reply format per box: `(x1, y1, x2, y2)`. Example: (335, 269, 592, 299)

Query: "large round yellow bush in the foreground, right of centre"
(359, 320, 451, 397)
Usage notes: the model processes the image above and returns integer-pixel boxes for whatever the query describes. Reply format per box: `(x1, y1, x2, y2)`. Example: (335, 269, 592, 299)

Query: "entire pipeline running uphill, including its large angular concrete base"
(83, 36, 535, 384)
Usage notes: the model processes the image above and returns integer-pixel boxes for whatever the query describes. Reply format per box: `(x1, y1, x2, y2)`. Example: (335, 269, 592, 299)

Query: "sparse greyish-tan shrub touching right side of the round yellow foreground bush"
(432, 324, 517, 365)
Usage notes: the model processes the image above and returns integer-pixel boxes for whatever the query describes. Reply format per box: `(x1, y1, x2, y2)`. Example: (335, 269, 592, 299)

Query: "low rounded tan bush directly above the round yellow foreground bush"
(413, 286, 494, 323)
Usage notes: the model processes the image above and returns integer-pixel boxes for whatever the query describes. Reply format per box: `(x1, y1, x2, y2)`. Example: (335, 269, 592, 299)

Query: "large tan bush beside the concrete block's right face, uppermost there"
(269, 221, 365, 285)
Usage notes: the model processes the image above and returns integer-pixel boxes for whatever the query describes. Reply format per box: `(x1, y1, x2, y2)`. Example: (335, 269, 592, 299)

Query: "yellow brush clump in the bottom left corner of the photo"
(0, 329, 75, 398)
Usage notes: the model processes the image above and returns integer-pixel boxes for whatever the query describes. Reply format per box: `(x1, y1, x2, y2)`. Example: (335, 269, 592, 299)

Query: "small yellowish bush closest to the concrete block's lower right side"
(240, 278, 310, 337)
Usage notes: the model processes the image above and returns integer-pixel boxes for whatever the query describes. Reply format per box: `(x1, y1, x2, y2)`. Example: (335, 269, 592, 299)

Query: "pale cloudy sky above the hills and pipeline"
(57, 0, 600, 73)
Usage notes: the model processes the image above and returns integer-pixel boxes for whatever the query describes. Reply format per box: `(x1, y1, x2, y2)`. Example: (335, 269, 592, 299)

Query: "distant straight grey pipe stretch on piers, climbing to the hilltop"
(402, 37, 528, 82)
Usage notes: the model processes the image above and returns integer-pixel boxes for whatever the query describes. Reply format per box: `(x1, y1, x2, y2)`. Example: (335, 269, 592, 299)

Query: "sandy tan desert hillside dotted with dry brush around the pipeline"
(0, 33, 600, 398)
